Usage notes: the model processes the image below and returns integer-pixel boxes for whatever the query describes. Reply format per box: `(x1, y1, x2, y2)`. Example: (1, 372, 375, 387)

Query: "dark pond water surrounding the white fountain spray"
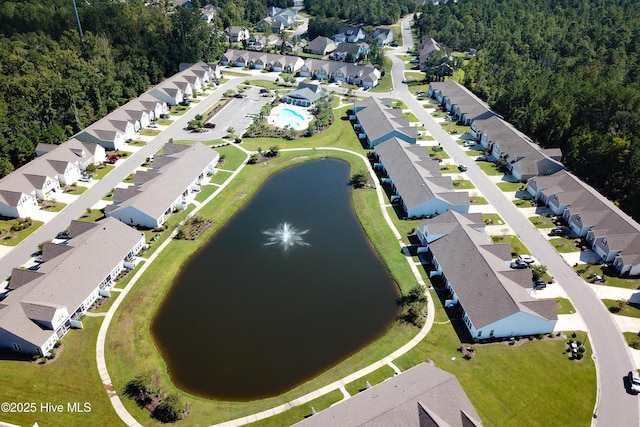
(151, 160, 398, 401)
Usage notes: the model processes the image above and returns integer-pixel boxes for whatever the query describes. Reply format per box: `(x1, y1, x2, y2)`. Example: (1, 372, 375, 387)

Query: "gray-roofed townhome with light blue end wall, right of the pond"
(417, 211, 558, 340)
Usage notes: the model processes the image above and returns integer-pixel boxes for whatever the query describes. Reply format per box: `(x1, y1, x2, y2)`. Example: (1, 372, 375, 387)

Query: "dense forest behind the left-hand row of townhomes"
(0, 0, 293, 177)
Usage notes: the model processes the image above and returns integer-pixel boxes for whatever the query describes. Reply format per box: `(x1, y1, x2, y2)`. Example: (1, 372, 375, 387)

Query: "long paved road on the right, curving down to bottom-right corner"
(389, 14, 640, 427)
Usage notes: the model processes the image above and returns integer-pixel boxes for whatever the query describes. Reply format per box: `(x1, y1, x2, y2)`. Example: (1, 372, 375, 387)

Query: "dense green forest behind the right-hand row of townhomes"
(415, 0, 640, 218)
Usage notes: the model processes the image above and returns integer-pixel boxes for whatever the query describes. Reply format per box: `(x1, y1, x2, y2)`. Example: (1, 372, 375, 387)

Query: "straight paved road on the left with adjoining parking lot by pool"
(0, 76, 264, 281)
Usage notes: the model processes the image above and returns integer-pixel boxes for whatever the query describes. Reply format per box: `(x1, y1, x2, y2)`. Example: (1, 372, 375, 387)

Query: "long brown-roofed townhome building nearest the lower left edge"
(0, 218, 145, 356)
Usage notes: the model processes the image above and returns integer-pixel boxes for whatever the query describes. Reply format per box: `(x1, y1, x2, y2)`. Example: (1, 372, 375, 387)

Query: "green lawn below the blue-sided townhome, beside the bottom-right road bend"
(394, 291, 596, 427)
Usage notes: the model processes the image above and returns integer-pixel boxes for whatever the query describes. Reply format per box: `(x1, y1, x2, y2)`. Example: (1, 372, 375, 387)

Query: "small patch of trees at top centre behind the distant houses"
(304, 0, 418, 25)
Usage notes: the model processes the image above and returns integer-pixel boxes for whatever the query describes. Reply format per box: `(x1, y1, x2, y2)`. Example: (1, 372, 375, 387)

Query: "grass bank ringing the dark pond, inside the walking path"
(107, 149, 418, 424)
